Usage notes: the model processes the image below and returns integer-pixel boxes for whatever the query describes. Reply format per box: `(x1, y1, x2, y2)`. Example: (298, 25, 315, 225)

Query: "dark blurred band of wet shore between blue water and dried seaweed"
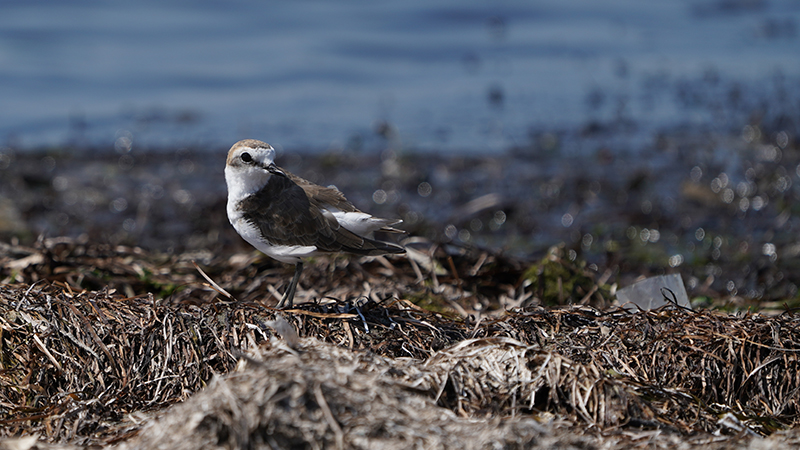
(0, 118, 800, 306)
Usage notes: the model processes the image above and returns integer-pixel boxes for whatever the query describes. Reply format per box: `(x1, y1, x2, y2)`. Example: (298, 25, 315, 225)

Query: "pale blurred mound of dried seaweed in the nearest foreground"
(119, 339, 564, 449)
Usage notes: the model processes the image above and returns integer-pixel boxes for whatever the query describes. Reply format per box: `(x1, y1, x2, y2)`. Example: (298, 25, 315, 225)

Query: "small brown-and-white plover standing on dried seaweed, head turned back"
(225, 139, 405, 308)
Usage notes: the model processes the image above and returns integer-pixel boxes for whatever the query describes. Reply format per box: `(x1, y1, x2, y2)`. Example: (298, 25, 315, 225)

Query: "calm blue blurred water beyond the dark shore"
(0, 0, 800, 152)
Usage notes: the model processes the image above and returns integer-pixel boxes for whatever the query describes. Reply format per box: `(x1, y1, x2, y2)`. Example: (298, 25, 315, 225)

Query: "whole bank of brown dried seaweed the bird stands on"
(0, 242, 800, 448)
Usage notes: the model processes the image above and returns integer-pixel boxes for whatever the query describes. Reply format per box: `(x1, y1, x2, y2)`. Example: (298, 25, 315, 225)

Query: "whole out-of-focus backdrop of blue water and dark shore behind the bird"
(0, 0, 800, 302)
